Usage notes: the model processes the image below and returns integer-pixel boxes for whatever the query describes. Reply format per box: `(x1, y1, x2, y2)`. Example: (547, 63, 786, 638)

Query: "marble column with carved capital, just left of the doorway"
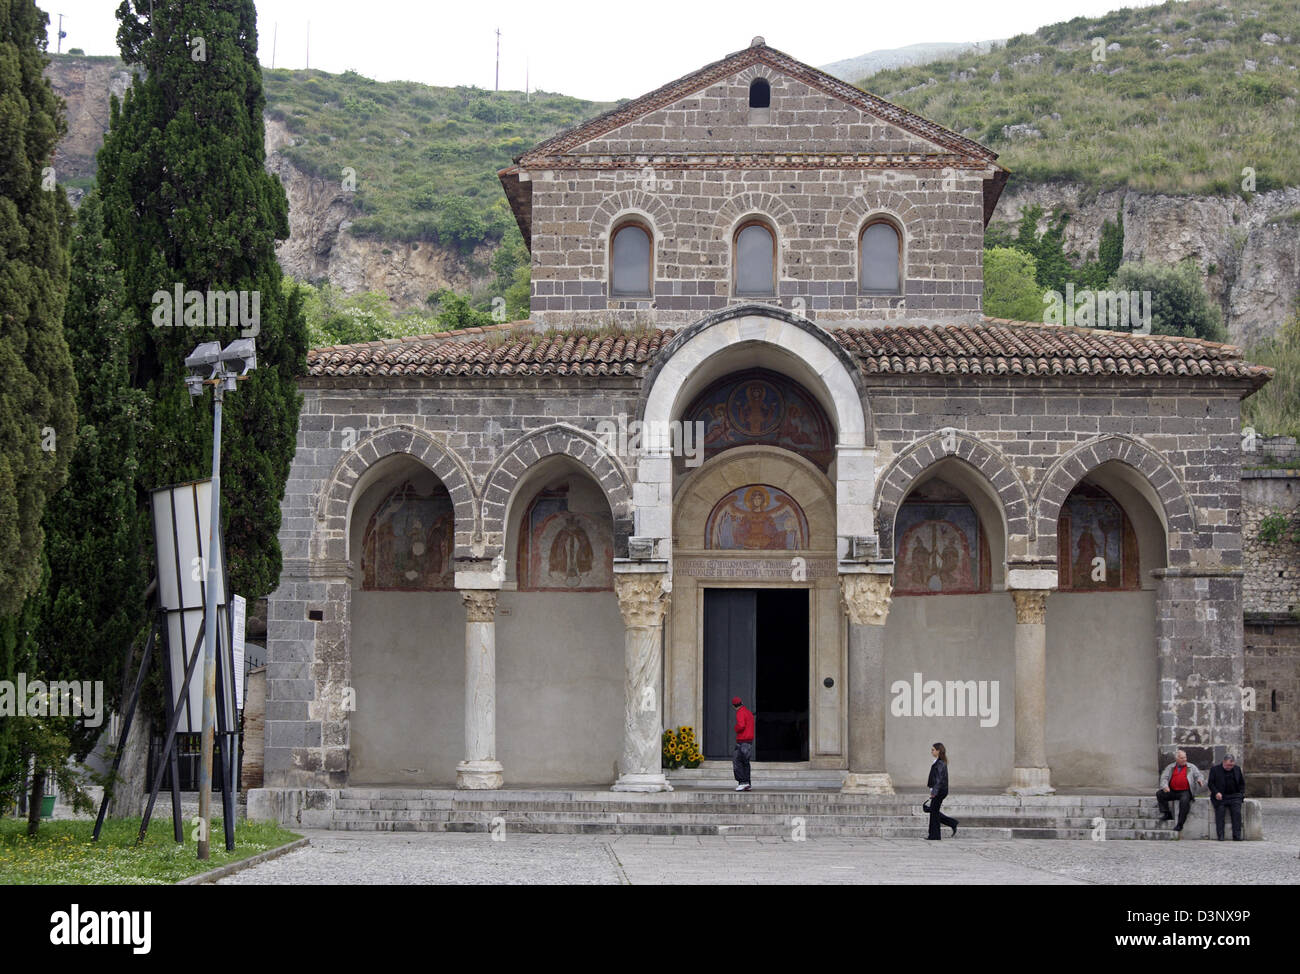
(612, 572, 672, 792)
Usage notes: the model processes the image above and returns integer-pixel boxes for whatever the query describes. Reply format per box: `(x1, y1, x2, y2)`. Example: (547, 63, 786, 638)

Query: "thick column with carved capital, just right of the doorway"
(840, 572, 894, 795)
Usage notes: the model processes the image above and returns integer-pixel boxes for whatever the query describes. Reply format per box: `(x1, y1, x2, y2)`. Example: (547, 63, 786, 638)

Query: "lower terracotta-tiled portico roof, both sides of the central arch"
(307, 319, 1273, 389)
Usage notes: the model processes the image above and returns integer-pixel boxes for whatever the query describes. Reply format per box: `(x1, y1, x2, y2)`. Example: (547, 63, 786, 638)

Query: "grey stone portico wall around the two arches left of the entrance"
(265, 377, 640, 787)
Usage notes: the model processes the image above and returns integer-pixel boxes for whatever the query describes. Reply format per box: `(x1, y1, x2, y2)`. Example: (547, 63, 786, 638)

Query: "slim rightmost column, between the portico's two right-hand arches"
(1006, 589, 1056, 795)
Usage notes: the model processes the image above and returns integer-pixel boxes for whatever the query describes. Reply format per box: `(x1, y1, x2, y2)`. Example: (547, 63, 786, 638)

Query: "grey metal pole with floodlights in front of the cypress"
(185, 338, 257, 860)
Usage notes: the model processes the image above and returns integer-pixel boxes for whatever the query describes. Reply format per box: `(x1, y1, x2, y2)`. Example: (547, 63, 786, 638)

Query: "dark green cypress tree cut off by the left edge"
(0, 0, 77, 616)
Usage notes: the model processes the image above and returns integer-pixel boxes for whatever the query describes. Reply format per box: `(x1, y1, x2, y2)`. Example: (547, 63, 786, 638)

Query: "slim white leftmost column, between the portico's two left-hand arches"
(456, 589, 503, 789)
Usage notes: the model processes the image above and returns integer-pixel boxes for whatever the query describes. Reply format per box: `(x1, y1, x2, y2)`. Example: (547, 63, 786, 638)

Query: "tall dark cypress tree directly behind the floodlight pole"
(99, 0, 307, 601)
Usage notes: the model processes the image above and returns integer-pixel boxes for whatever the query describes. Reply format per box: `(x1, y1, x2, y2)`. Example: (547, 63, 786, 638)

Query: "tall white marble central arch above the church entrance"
(634, 304, 875, 558)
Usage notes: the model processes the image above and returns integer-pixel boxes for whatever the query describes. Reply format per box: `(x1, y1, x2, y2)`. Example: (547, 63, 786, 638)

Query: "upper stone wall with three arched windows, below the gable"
(532, 169, 984, 326)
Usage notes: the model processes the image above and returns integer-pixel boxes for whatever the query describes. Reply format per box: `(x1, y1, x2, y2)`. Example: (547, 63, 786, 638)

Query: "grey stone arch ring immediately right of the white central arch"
(876, 429, 1030, 574)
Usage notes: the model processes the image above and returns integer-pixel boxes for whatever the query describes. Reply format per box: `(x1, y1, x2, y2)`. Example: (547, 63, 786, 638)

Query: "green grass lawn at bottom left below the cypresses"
(0, 818, 300, 886)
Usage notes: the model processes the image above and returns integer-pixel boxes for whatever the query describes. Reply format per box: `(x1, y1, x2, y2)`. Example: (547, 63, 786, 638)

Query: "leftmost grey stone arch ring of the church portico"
(312, 425, 478, 562)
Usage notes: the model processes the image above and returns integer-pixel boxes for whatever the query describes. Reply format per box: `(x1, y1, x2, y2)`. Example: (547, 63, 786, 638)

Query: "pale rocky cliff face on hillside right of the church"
(993, 183, 1300, 345)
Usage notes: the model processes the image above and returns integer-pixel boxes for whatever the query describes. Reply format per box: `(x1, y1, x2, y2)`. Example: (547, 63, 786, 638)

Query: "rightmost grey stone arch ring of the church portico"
(1034, 434, 1196, 561)
